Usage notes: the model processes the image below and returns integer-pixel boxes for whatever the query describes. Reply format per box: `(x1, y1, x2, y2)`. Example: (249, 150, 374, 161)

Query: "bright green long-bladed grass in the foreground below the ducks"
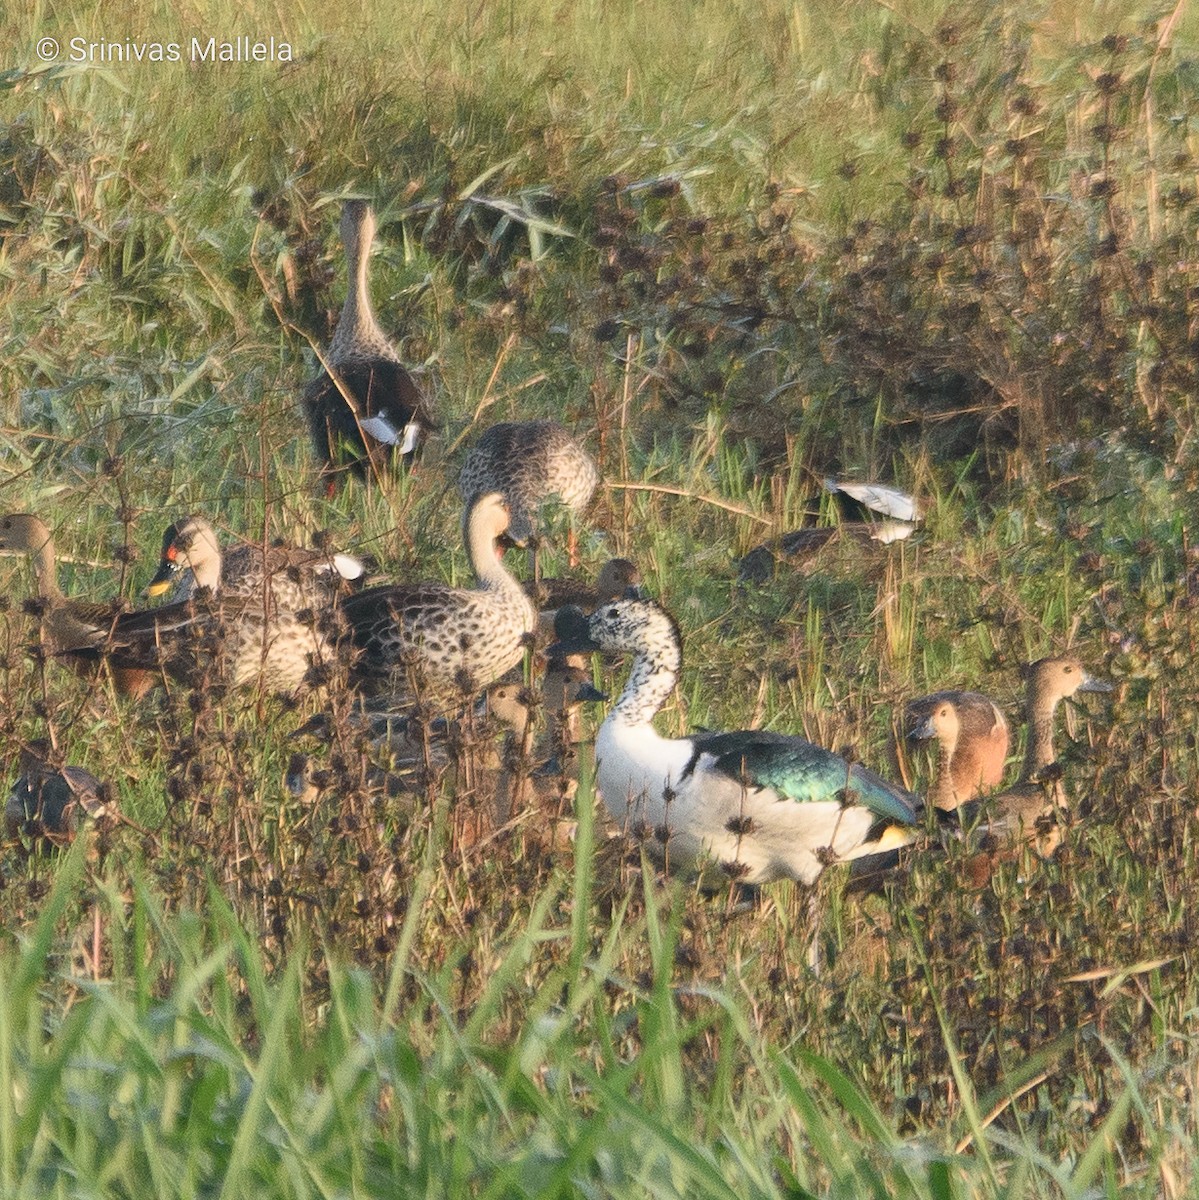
(0, 853, 1171, 1198)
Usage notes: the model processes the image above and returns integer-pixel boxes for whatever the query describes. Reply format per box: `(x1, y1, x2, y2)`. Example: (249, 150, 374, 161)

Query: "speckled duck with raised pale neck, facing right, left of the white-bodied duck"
(338, 492, 536, 702)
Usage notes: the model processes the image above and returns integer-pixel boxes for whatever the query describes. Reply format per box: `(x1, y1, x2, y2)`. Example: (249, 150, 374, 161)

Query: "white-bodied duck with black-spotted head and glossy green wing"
(558, 599, 917, 884)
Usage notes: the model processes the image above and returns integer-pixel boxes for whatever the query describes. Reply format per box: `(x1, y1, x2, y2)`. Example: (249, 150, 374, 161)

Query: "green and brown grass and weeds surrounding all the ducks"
(0, 0, 1199, 1198)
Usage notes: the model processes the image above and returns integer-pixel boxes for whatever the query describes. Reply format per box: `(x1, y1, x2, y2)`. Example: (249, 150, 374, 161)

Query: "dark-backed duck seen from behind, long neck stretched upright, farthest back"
(304, 200, 436, 487)
